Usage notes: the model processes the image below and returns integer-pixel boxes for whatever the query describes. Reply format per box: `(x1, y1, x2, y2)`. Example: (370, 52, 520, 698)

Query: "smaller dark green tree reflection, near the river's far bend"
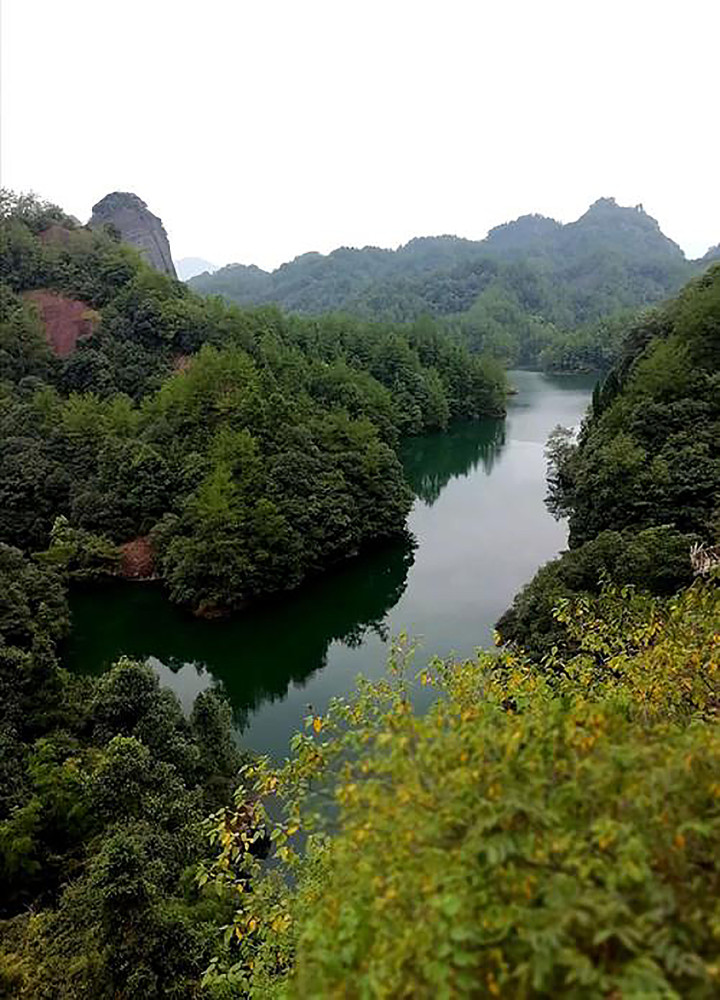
(402, 420, 505, 505)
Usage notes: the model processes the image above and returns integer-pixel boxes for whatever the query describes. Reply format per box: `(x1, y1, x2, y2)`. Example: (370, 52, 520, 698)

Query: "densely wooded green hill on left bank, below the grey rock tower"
(0, 187, 504, 614)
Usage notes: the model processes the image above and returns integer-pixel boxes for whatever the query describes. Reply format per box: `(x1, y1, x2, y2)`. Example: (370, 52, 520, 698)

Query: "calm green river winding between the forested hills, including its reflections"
(67, 372, 593, 756)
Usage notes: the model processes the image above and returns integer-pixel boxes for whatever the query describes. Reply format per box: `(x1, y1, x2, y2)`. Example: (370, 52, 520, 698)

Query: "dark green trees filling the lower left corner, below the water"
(0, 545, 240, 1000)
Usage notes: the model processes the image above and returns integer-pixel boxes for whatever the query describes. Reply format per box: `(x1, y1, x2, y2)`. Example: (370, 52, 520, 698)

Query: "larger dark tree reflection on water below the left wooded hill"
(68, 537, 414, 727)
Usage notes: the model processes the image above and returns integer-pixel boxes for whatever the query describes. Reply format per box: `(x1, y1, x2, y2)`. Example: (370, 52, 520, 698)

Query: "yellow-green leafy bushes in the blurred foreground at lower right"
(202, 584, 720, 1000)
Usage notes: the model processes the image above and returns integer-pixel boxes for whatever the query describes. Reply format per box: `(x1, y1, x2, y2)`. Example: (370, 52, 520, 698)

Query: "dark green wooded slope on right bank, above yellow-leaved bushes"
(499, 266, 720, 654)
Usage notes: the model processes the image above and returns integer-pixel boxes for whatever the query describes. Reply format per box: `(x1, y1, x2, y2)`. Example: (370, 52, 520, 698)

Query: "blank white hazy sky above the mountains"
(0, 0, 720, 267)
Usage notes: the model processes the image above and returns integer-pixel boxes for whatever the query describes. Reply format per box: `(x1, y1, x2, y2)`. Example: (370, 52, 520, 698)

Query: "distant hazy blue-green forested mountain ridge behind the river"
(191, 198, 701, 371)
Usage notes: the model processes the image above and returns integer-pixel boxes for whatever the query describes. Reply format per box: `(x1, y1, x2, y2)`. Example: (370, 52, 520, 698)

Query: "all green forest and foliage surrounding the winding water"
(0, 192, 720, 1000)
